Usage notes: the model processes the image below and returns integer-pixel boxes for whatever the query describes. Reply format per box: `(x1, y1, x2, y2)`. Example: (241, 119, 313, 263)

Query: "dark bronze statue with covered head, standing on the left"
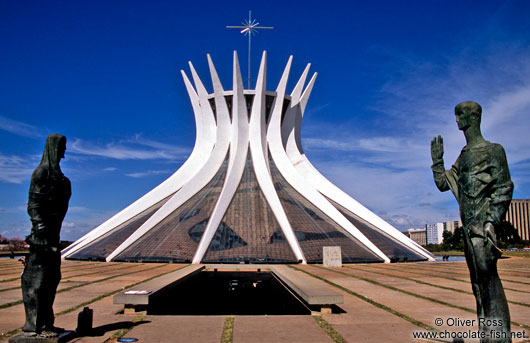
(22, 134, 71, 338)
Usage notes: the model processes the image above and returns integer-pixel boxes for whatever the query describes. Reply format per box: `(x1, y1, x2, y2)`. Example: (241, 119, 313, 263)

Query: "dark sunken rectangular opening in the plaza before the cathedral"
(147, 271, 311, 315)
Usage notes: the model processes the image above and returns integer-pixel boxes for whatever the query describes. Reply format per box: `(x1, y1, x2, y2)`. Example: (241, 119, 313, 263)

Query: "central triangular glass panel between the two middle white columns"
(197, 153, 297, 263)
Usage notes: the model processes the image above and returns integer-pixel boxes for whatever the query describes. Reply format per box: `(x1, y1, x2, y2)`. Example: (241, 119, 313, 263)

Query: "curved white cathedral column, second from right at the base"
(267, 56, 390, 262)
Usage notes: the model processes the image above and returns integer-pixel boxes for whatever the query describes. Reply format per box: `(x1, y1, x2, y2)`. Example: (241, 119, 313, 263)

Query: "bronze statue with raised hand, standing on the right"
(431, 101, 513, 342)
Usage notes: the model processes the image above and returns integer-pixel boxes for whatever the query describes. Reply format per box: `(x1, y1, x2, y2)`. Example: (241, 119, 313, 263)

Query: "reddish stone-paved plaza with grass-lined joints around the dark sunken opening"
(0, 257, 530, 343)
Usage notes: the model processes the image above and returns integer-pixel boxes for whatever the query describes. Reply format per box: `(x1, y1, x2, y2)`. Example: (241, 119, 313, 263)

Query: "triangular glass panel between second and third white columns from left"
(115, 156, 228, 262)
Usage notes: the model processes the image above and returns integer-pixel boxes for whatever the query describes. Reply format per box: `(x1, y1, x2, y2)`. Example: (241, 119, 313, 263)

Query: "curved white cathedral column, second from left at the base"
(107, 59, 230, 261)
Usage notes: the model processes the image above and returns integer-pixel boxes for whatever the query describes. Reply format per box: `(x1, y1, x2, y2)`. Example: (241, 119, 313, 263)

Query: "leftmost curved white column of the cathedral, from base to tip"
(62, 64, 216, 259)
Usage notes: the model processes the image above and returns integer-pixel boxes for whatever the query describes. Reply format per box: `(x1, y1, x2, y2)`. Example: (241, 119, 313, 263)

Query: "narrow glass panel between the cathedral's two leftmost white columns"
(67, 194, 173, 261)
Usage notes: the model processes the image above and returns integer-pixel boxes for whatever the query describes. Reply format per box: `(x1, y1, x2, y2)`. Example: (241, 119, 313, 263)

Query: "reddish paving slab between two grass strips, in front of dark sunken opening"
(234, 316, 333, 343)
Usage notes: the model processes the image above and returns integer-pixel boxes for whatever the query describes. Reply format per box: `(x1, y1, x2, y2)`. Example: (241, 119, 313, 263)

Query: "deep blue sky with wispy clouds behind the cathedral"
(0, 0, 530, 239)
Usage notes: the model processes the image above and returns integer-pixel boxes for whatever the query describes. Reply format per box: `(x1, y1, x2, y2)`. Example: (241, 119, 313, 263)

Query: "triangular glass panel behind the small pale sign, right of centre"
(269, 158, 382, 263)
